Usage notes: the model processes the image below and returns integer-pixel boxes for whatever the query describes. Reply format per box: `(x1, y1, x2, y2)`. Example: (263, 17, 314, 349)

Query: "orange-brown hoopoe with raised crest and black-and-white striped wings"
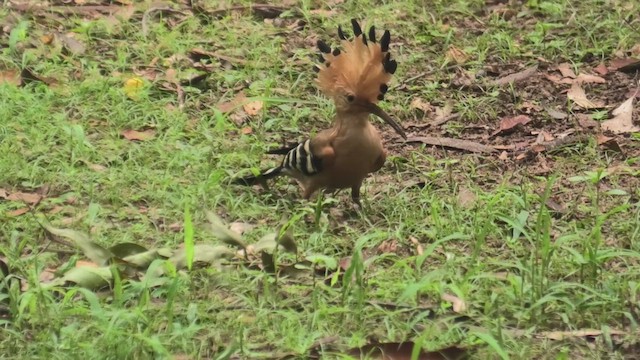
(234, 19, 407, 205)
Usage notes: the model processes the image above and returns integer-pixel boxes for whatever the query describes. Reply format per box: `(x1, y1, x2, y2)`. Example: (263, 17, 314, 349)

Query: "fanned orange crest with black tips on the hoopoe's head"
(316, 19, 398, 104)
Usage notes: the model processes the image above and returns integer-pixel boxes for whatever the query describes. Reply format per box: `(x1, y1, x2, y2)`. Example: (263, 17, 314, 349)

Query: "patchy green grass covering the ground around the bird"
(0, 0, 640, 359)
